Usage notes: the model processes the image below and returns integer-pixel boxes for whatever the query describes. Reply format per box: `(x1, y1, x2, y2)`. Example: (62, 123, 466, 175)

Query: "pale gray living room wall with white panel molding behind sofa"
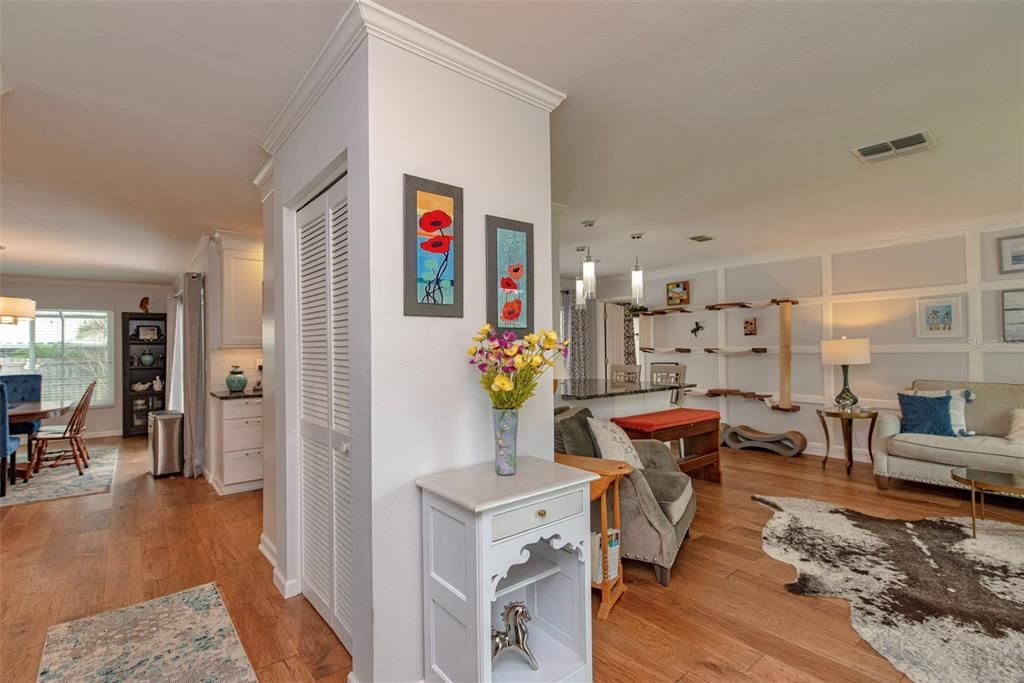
(600, 215, 1024, 462)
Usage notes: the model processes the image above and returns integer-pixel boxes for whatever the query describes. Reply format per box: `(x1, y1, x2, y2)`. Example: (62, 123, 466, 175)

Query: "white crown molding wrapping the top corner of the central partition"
(261, 0, 565, 156)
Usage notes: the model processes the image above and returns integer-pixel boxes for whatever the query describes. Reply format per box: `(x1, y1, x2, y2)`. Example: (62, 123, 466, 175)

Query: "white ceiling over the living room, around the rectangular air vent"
(386, 0, 1024, 274)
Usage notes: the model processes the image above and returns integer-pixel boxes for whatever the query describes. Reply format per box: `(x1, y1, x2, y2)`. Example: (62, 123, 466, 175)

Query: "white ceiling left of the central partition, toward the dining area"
(0, 0, 347, 282)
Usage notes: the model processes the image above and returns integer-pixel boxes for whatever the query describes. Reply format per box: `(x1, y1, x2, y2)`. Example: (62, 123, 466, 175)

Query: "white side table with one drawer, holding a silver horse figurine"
(416, 457, 597, 683)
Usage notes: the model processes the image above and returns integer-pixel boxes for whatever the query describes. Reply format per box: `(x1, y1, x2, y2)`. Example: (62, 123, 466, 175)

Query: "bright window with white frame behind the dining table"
(0, 310, 115, 408)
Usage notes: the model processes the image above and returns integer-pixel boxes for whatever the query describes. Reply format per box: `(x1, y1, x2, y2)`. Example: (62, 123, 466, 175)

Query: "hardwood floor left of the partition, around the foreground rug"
(0, 438, 351, 683)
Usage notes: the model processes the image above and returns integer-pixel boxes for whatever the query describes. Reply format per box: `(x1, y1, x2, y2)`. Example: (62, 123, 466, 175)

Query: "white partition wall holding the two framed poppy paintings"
(255, 0, 564, 683)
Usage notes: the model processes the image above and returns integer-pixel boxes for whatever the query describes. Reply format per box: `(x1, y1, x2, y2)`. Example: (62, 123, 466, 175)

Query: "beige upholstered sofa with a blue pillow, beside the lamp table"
(874, 380, 1024, 488)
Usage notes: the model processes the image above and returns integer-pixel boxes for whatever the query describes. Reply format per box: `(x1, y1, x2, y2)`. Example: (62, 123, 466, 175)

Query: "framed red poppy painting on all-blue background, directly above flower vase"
(484, 216, 534, 337)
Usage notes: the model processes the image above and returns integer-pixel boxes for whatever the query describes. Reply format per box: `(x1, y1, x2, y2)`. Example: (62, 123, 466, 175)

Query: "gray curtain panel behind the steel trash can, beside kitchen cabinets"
(181, 272, 206, 477)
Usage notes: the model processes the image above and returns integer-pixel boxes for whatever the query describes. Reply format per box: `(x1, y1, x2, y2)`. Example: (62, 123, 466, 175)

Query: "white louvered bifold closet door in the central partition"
(296, 178, 353, 648)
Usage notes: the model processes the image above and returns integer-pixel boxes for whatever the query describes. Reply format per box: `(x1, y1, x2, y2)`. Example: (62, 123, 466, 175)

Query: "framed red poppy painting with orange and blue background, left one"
(403, 175, 463, 317)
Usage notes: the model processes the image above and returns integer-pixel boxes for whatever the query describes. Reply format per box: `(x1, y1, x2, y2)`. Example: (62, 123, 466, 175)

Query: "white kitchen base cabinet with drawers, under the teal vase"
(206, 391, 263, 496)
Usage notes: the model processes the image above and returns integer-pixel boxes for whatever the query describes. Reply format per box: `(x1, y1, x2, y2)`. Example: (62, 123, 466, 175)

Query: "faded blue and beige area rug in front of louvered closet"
(37, 584, 256, 683)
